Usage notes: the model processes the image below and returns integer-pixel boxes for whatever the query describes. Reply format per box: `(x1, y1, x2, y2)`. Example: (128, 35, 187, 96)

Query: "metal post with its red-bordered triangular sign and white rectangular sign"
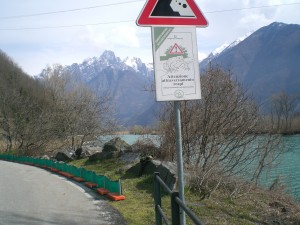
(136, 0, 208, 225)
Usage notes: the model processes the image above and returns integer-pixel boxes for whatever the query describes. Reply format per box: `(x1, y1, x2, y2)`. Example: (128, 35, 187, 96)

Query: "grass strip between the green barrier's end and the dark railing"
(70, 159, 155, 225)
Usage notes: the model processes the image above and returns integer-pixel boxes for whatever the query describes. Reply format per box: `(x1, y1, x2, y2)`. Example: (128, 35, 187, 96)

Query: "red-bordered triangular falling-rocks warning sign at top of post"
(136, 0, 208, 27)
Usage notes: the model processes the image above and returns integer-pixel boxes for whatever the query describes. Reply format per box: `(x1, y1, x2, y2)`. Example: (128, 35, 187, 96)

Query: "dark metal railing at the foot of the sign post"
(154, 173, 204, 225)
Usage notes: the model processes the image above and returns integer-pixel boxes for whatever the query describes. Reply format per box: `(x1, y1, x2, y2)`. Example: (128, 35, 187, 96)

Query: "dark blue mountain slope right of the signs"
(200, 22, 300, 105)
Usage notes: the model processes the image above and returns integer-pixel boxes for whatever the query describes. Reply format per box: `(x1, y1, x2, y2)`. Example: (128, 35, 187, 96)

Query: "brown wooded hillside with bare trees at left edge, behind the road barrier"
(0, 51, 114, 155)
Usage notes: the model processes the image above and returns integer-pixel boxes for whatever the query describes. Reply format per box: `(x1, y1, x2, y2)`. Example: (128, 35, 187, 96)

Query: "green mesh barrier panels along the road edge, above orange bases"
(0, 155, 122, 195)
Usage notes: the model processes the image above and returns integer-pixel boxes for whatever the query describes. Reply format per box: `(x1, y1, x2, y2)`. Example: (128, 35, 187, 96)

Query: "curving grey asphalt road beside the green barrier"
(0, 161, 126, 225)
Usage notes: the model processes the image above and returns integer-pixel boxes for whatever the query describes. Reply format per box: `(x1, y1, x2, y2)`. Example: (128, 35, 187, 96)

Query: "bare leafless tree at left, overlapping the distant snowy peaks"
(44, 65, 116, 149)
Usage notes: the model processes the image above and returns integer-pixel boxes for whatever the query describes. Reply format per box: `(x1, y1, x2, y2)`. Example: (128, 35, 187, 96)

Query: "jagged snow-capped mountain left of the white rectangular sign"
(41, 51, 156, 126)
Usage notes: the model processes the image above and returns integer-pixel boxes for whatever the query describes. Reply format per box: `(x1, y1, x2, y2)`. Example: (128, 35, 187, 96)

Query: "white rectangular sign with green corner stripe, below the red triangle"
(152, 27, 201, 101)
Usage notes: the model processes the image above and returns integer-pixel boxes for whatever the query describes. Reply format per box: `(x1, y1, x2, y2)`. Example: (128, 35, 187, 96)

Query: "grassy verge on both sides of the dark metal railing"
(70, 159, 300, 225)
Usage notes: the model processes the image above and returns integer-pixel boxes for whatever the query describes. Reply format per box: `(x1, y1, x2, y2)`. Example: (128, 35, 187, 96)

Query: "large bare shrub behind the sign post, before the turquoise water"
(161, 68, 282, 198)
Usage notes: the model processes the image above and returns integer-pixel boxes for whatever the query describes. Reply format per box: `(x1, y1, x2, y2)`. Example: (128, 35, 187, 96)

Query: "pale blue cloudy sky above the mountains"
(0, 0, 300, 75)
